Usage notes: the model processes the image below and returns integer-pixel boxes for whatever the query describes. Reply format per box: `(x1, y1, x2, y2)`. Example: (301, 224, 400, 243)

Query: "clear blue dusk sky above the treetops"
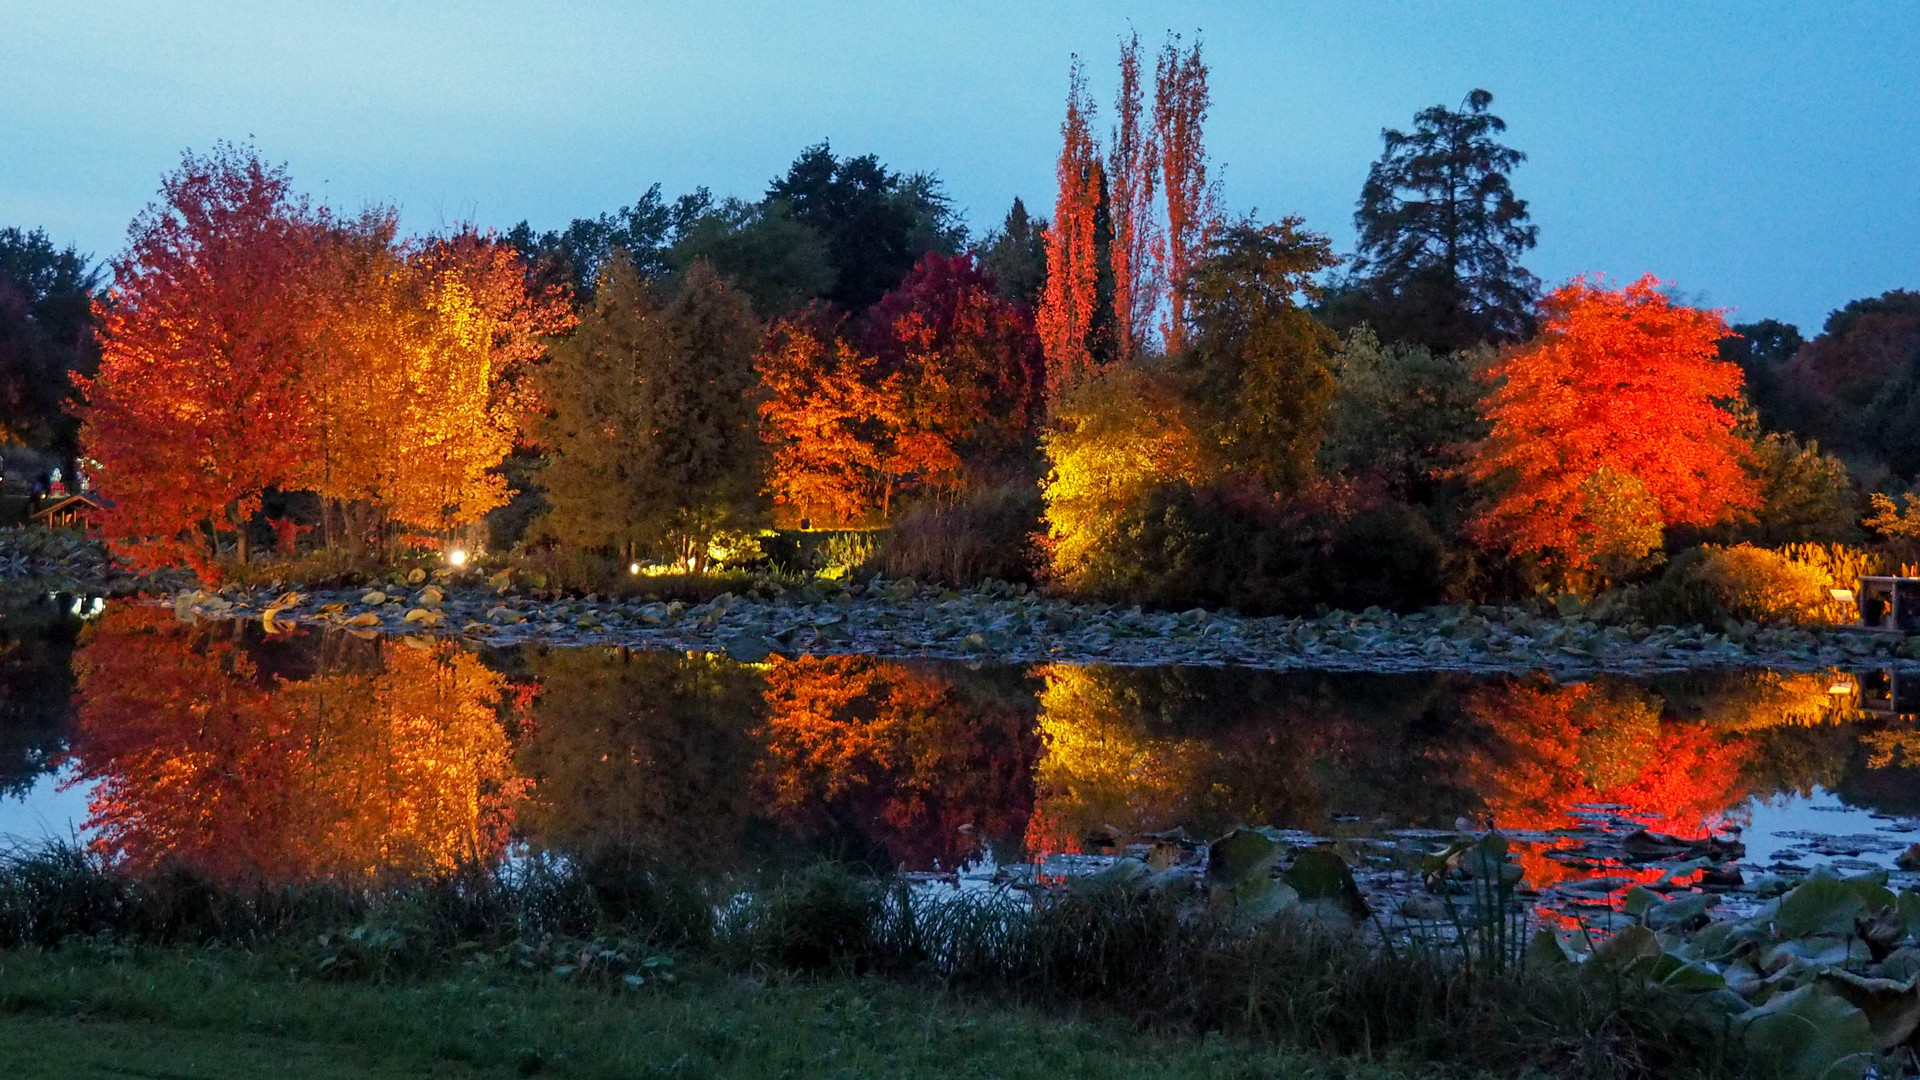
(0, 0, 1920, 331)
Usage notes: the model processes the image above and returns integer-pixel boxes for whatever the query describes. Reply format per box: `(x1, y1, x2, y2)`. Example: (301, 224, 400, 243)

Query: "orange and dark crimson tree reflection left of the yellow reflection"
(760, 645, 1035, 867)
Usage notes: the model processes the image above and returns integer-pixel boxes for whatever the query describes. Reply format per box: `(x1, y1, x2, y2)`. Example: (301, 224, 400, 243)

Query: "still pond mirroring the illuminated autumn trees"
(0, 598, 1920, 909)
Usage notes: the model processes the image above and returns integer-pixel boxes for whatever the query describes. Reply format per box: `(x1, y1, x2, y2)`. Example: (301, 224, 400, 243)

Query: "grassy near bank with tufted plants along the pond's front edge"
(0, 830, 1827, 1078)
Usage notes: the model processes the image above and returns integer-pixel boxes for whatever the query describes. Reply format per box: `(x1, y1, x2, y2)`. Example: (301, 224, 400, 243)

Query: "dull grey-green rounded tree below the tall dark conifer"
(1321, 325, 1486, 498)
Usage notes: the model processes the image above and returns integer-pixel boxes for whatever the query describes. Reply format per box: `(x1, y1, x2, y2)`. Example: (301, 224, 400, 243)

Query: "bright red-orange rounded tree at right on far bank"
(1467, 275, 1757, 582)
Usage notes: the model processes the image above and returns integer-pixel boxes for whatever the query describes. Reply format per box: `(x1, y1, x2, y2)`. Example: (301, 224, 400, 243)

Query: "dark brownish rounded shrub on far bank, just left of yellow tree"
(876, 484, 1041, 586)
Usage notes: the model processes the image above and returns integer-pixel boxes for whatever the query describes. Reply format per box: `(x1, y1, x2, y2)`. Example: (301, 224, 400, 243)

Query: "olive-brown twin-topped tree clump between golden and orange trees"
(540, 259, 760, 567)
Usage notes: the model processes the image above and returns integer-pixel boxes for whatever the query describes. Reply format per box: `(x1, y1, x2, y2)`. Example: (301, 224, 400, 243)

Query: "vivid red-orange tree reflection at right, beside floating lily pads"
(1465, 682, 1753, 884)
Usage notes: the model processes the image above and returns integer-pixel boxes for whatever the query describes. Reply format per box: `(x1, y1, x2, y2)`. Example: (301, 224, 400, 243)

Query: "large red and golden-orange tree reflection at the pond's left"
(71, 609, 522, 880)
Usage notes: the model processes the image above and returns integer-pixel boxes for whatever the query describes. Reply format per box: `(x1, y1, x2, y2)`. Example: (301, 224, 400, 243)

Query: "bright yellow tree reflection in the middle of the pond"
(1027, 663, 1210, 853)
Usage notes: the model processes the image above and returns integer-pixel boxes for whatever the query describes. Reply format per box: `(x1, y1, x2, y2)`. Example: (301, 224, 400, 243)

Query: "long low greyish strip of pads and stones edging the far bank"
(171, 575, 1920, 675)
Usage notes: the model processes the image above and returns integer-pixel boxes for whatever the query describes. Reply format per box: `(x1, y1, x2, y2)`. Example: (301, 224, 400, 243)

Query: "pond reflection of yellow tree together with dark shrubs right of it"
(1027, 665, 1473, 851)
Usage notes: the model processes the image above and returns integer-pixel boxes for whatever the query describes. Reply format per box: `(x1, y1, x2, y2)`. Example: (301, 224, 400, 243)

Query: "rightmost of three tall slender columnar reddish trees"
(1154, 35, 1219, 356)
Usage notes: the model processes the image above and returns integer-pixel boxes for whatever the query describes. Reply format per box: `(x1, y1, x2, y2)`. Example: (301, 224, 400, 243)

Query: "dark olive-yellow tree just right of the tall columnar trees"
(1177, 217, 1340, 492)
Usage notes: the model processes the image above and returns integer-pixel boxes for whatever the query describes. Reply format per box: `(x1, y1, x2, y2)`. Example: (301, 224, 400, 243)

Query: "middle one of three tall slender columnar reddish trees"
(1106, 35, 1164, 363)
